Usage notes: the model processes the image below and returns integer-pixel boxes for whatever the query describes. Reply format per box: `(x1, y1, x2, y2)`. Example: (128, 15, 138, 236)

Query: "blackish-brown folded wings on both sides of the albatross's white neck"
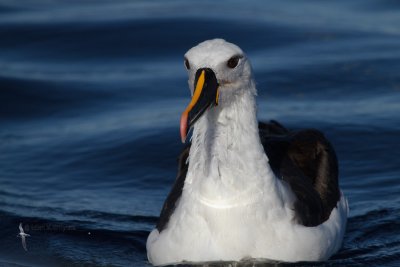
(157, 121, 340, 232)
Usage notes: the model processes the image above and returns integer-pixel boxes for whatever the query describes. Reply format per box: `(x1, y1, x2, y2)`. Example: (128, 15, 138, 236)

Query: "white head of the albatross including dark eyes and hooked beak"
(180, 39, 256, 142)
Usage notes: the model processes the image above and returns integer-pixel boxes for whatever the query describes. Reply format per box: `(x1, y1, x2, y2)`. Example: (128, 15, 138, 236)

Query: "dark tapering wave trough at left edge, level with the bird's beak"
(0, 77, 112, 121)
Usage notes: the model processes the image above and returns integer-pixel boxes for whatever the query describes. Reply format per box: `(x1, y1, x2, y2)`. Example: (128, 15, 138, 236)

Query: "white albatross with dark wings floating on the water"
(146, 39, 348, 265)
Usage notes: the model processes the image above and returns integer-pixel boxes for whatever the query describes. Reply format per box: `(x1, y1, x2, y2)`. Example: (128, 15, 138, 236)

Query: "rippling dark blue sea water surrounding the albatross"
(0, 0, 400, 266)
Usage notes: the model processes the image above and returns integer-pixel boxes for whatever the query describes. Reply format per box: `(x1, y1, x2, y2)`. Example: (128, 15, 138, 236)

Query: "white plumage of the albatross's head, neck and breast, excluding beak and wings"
(147, 39, 348, 265)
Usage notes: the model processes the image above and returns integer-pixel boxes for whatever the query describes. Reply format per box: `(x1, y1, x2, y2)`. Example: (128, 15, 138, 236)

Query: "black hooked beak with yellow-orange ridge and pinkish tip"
(180, 68, 219, 143)
